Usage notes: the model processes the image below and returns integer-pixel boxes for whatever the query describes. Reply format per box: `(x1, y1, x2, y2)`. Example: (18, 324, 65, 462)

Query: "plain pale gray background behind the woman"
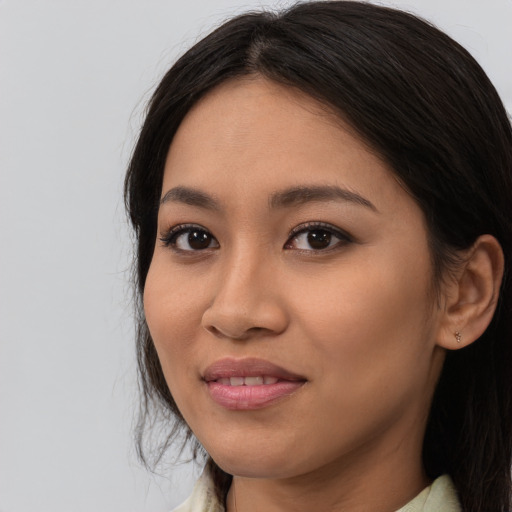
(0, 0, 512, 512)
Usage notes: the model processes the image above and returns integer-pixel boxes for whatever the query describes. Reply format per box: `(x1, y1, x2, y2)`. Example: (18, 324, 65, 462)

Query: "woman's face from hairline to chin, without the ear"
(144, 79, 443, 478)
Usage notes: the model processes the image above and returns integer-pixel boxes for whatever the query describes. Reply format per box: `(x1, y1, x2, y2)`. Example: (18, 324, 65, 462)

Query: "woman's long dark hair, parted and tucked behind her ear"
(125, 1, 512, 512)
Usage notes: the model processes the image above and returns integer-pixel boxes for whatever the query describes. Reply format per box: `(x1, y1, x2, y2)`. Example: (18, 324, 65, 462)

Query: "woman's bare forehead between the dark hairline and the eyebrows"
(162, 78, 412, 216)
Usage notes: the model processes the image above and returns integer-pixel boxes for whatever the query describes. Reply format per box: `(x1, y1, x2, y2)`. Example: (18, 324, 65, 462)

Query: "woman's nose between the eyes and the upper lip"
(202, 252, 288, 340)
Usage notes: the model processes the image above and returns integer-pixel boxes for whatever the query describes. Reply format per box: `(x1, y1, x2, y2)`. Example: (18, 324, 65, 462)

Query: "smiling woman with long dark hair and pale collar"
(126, 1, 512, 512)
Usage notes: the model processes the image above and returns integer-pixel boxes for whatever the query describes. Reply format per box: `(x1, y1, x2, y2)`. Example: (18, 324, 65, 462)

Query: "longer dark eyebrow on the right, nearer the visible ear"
(270, 185, 378, 212)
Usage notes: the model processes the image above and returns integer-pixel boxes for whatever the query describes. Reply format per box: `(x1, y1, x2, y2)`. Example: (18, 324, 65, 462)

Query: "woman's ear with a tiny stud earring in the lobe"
(437, 235, 504, 350)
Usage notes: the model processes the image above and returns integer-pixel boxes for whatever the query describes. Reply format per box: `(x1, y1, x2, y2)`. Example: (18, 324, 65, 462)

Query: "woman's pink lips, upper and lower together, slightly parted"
(203, 358, 306, 411)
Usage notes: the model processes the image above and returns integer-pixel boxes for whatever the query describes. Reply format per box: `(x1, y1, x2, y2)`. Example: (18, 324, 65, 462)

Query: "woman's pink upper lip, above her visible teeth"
(203, 357, 306, 382)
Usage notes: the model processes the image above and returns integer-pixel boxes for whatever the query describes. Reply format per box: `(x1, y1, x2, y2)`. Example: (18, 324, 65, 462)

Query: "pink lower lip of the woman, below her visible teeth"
(207, 380, 305, 411)
